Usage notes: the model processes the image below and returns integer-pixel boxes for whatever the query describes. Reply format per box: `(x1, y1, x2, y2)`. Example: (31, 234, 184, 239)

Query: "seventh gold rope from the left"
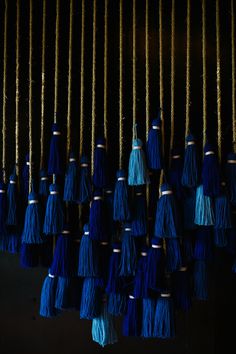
(79, 0, 85, 156)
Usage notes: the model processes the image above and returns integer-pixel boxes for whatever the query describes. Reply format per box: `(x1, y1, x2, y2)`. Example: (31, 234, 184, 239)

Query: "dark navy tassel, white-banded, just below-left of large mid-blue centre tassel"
(147, 237, 165, 292)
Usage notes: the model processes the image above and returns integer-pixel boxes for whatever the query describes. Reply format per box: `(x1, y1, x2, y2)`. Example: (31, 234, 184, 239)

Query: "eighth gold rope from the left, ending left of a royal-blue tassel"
(91, 0, 97, 175)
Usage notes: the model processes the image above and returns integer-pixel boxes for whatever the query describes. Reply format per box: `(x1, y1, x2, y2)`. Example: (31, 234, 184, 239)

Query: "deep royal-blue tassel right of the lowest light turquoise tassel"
(123, 295, 142, 337)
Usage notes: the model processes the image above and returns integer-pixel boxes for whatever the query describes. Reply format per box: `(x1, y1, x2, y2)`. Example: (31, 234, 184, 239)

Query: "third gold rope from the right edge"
(202, 0, 207, 148)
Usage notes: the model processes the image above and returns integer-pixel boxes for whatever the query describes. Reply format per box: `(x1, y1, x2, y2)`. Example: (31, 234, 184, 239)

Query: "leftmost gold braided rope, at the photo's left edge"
(2, 1, 8, 183)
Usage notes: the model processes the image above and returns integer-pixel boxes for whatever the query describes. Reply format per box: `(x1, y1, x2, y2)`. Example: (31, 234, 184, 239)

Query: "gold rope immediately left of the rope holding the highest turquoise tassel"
(119, 0, 124, 169)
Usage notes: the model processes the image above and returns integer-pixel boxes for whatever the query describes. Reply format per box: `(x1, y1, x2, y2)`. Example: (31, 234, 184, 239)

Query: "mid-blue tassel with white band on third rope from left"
(22, 192, 43, 244)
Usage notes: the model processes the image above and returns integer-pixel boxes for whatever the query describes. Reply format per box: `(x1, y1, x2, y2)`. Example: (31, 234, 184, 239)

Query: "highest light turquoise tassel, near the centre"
(128, 139, 150, 186)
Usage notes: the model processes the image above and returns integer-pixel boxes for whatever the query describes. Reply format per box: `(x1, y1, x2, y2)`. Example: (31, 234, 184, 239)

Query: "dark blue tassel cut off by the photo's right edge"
(226, 152, 236, 205)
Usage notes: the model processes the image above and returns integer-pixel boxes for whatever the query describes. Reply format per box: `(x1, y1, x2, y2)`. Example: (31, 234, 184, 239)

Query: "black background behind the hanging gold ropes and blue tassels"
(0, 0, 236, 354)
